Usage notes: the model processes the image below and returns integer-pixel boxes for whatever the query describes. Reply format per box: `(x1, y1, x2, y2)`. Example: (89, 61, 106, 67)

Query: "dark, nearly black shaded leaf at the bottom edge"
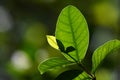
(55, 70, 82, 80)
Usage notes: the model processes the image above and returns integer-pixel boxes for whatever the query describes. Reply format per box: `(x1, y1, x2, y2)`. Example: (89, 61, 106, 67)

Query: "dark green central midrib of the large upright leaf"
(68, 7, 79, 61)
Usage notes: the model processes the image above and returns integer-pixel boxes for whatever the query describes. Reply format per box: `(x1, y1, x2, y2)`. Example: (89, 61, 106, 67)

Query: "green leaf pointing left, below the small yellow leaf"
(38, 58, 72, 74)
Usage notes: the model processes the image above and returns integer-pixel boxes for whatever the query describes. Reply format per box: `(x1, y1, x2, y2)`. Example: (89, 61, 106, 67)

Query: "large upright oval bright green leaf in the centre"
(55, 5, 89, 61)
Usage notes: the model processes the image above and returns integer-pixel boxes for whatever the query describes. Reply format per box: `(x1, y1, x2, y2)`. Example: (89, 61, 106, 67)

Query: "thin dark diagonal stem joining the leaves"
(67, 53, 96, 80)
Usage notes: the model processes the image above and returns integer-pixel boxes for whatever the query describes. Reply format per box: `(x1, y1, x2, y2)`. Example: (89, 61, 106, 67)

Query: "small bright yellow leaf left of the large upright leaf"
(46, 35, 58, 49)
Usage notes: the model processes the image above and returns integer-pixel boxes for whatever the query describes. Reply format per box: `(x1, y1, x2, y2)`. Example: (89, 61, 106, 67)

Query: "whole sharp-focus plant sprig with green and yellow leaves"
(38, 5, 120, 80)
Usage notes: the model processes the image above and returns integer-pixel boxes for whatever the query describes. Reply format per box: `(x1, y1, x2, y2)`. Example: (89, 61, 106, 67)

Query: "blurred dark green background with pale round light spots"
(0, 0, 120, 80)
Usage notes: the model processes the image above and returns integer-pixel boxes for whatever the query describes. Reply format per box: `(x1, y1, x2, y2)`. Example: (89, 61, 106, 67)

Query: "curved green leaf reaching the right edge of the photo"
(92, 40, 120, 73)
